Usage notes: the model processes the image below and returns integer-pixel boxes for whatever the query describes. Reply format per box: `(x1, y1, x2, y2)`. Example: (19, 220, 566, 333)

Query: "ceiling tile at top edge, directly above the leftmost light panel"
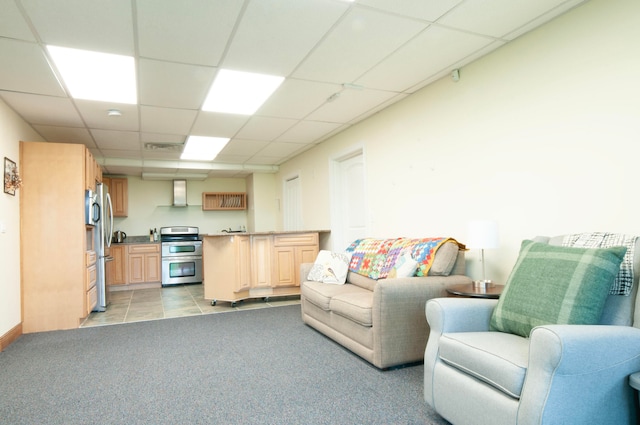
(22, 0, 134, 55)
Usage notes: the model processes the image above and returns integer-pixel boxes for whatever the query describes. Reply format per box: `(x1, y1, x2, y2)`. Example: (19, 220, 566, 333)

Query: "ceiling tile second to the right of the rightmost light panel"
(307, 89, 397, 123)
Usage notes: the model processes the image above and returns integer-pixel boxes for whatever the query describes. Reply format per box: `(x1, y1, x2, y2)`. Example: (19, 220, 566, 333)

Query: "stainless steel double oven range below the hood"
(160, 226, 202, 286)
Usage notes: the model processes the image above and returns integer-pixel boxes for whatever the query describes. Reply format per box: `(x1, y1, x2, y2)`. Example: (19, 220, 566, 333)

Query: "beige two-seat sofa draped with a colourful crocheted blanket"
(300, 243, 471, 369)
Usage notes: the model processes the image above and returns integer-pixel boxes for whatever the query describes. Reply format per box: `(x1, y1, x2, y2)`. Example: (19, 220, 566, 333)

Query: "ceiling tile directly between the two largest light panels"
(138, 59, 215, 109)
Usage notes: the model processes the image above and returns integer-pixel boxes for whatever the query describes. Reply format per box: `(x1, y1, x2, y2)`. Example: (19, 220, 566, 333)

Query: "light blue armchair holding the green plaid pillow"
(424, 237, 640, 425)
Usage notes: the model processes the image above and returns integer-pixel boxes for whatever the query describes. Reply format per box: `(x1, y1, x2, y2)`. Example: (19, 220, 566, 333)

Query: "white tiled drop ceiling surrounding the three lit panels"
(0, 0, 584, 177)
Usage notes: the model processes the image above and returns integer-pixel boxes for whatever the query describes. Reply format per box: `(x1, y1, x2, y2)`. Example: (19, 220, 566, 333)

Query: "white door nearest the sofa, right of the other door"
(331, 149, 369, 251)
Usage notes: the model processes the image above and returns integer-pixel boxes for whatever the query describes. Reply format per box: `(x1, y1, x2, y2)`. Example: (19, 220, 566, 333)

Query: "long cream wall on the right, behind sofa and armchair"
(276, 0, 640, 281)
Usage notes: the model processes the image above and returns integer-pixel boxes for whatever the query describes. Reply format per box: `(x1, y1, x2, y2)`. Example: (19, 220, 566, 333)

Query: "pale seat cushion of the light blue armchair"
(438, 332, 529, 398)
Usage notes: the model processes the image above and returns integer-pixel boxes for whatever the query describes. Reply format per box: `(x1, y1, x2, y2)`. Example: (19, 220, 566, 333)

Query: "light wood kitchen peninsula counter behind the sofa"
(201, 230, 329, 306)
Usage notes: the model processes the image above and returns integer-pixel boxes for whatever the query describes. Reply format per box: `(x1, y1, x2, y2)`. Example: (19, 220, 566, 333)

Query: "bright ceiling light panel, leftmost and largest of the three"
(47, 46, 137, 104)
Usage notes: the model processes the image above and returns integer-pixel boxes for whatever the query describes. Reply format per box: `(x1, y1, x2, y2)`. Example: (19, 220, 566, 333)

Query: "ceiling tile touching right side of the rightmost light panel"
(258, 79, 342, 119)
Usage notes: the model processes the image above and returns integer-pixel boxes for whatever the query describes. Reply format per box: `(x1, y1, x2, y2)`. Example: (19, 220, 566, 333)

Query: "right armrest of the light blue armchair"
(518, 325, 640, 424)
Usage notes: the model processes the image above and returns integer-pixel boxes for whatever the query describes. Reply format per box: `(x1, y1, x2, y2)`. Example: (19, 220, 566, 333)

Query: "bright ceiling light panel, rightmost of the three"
(202, 69, 284, 115)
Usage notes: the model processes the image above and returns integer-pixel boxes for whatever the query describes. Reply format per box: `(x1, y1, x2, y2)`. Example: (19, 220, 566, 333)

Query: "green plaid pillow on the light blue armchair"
(490, 240, 627, 337)
